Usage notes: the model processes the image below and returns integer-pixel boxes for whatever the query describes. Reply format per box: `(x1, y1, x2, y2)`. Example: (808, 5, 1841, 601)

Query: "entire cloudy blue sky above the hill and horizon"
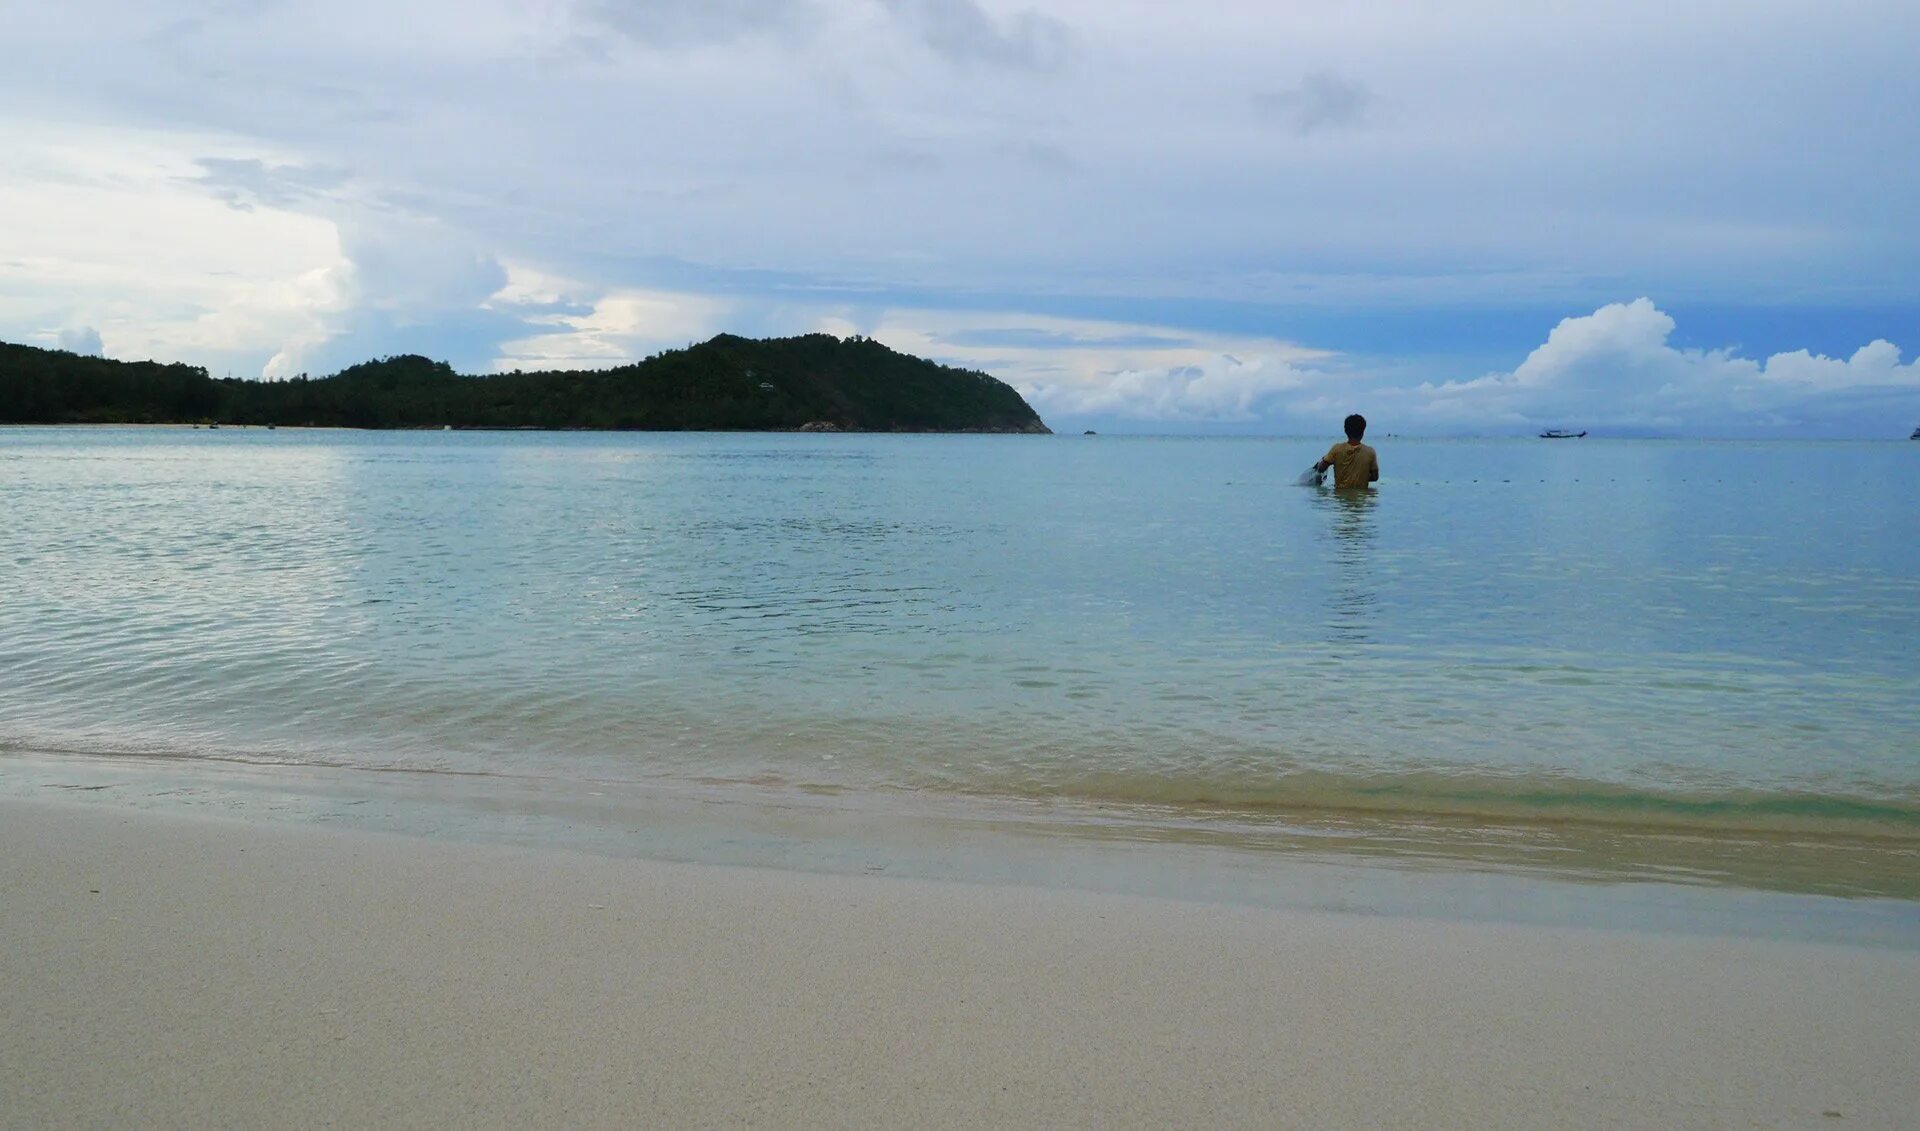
(0, 0, 1920, 436)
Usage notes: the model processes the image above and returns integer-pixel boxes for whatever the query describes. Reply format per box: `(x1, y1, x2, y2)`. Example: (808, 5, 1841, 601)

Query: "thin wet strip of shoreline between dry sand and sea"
(0, 751, 1920, 952)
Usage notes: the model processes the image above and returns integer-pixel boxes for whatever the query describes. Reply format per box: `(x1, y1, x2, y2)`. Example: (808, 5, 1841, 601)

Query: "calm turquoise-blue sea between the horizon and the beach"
(0, 426, 1920, 939)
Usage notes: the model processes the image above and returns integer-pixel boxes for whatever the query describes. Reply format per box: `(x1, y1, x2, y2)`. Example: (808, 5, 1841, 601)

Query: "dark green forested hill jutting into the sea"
(0, 334, 1048, 432)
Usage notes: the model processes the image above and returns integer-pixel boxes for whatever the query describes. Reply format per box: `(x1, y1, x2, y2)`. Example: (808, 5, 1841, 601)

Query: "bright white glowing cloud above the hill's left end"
(0, 117, 528, 376)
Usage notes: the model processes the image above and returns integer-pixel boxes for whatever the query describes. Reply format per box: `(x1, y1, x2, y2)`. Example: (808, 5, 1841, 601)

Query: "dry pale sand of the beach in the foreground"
(0, 801, 1920, 1129)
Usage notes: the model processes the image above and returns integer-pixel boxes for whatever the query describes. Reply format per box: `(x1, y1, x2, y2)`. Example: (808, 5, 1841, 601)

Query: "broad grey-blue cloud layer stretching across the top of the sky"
(0, 0, 1920, 324)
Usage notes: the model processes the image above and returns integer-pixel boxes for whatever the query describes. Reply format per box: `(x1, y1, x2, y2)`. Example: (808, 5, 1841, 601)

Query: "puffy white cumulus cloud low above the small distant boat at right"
(1394, 298, 1920, 434)
